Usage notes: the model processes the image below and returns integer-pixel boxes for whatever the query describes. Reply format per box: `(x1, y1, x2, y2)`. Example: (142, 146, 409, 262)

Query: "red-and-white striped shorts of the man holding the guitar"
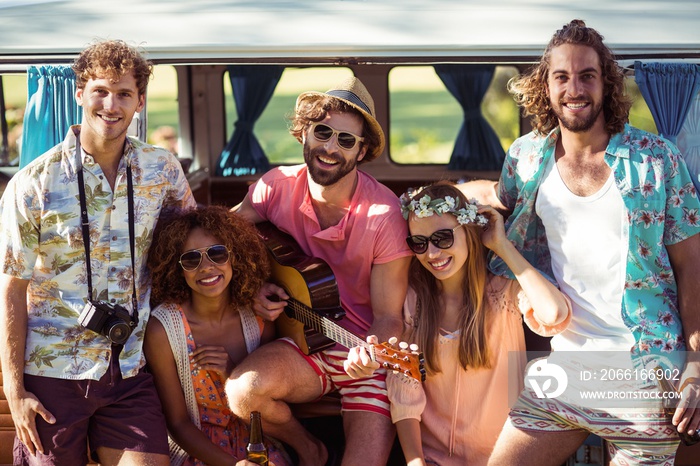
(278, 338, 391, 418)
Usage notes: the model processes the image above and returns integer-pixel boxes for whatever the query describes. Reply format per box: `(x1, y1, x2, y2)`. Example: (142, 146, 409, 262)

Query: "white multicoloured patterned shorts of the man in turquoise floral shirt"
(507, 387, 679, 466)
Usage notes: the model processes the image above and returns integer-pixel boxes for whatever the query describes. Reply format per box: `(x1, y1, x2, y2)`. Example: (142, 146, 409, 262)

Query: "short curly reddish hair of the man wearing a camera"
(73, 40, 153, 95)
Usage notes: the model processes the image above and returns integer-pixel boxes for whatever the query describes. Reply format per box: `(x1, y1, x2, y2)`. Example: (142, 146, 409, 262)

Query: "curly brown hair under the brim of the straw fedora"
(289, 96, 381, 163)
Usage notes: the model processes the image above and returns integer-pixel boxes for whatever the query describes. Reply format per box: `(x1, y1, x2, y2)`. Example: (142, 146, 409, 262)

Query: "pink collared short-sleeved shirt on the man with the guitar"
(248, 165, 412, 337)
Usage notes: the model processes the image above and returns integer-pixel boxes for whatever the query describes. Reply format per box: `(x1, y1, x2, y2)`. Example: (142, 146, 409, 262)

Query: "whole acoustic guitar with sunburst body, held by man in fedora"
(256, 222, 425, 381)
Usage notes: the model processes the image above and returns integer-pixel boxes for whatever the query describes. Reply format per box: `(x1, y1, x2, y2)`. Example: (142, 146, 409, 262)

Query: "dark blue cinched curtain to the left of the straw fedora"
(216, 65, 284, 176)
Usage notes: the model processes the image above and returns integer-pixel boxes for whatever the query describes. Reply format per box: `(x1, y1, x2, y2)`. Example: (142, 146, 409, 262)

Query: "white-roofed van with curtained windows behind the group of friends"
(0, 0, 700, 465)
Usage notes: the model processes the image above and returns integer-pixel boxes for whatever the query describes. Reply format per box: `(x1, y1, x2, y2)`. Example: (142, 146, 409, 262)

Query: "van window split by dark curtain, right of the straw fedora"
(389, 66, 520, 164)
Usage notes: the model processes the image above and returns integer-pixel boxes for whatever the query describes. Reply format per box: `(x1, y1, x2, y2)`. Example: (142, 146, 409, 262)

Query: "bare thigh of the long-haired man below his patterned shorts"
(489, 422, 588, 466)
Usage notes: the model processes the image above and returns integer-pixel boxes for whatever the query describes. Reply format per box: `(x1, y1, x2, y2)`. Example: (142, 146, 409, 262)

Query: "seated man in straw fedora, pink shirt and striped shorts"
(226, 77, 411, 466)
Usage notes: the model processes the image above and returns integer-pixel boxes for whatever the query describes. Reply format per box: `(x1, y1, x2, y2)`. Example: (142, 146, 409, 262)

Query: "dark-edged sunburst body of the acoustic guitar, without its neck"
(256, 222, 345, 354)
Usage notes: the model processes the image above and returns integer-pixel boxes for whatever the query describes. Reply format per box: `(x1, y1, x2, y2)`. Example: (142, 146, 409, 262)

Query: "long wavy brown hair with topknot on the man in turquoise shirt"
(508, 19, 632, 135)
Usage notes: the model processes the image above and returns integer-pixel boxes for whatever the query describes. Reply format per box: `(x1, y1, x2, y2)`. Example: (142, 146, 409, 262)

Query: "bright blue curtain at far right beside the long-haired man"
(634, 61, 700, 143)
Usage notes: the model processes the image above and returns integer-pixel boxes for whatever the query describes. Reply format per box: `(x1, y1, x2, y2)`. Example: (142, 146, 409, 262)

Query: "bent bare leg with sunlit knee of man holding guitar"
(226, 342, 328, 466)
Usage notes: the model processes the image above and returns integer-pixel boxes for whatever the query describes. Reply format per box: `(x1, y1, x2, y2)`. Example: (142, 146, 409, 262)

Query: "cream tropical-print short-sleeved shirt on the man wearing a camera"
(0, 126, 196, 380)
